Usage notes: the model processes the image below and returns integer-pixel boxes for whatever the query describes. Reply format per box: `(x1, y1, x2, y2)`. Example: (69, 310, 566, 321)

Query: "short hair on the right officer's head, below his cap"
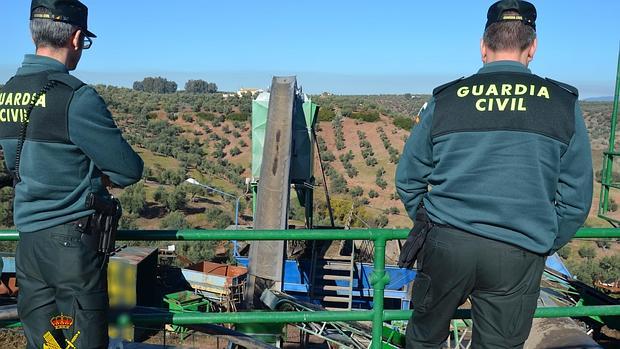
(482, 11, 536, 51)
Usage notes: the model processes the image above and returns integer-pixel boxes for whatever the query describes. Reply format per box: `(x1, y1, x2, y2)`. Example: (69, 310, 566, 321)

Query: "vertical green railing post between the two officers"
(370, 231, 389, 349)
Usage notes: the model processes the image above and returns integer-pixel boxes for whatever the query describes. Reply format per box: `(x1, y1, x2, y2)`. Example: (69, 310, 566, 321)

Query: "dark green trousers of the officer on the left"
(15, 222, 108, 349)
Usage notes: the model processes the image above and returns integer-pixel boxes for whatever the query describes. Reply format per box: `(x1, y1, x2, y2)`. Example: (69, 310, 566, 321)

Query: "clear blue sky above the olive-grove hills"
(0, 0, 620, 97)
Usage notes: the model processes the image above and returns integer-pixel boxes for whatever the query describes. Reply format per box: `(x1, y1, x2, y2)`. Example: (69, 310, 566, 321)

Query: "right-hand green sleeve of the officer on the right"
(550, 102, 593, 253)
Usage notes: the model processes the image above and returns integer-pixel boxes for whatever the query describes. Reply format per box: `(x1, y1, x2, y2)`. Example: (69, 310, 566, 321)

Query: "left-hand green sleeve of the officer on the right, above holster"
(396, 98, 435, 220)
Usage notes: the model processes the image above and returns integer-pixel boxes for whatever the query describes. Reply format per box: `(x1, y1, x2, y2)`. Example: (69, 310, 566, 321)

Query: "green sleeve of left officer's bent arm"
(69, 86, 144, 187)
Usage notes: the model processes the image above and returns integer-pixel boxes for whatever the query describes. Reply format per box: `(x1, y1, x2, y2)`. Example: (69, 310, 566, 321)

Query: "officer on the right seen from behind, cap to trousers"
(396, 0, 592, 348)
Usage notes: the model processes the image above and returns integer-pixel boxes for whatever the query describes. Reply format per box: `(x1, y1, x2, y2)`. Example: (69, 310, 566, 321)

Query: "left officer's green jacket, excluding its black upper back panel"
(0, 55, 144, 232)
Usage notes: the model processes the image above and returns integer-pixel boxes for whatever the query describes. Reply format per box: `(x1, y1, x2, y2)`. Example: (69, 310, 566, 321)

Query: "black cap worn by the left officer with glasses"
(30, 0, 97, 38)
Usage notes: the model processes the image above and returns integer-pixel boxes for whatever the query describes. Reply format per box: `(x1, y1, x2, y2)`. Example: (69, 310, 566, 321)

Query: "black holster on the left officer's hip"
(81, 193, 123, 256)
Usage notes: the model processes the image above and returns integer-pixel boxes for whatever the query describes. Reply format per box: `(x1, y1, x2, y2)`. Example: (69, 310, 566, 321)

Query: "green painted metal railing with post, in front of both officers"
(0, 228, 620, 349)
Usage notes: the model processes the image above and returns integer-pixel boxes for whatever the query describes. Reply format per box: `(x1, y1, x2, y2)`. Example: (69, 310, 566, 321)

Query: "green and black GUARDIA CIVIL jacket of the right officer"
(396, 61, 593, 254)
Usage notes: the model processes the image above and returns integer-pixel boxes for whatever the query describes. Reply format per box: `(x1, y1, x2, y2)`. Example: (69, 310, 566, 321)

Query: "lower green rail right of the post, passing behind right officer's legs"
(383, 305, 620, 321)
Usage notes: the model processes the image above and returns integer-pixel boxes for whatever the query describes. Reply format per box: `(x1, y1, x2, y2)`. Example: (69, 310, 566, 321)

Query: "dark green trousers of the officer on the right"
(406, 227, 545, 349)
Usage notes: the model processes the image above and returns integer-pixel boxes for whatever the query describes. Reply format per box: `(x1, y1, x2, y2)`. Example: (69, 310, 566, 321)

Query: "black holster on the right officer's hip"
(398, 203, 435, 269)
